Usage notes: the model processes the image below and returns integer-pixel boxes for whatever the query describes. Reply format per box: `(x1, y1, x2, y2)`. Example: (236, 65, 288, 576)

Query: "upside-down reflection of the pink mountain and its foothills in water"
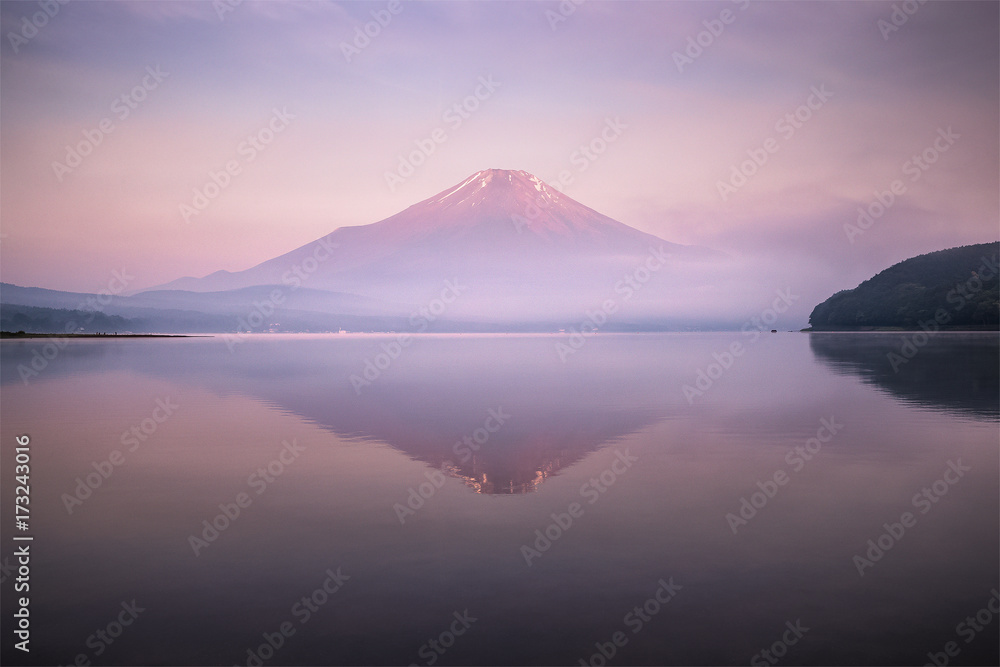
(3, 336, 676, 494)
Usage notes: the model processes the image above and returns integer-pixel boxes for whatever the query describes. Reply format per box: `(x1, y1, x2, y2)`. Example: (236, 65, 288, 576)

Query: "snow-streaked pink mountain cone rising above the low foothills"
(146, 169, 724, 320)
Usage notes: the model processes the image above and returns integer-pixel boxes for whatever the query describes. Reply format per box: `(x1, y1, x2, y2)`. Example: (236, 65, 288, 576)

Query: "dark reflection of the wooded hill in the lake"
(809, 332, 1000, 419)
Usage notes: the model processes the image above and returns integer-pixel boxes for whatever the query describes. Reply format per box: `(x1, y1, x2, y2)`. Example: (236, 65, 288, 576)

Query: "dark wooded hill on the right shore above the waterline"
(809, 243, 1000, 330)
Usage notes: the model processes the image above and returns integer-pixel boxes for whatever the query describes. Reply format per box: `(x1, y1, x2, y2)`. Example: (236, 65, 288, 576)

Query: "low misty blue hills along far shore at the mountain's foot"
(0, 282, 727, 334)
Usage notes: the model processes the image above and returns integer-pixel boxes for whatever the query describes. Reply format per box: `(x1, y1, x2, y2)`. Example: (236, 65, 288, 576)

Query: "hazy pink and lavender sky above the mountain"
(0, 0, 1000, 300)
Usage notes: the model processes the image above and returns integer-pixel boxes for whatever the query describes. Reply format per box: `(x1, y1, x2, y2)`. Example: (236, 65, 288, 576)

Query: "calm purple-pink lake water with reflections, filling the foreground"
(0, 333, 1000, 665)
